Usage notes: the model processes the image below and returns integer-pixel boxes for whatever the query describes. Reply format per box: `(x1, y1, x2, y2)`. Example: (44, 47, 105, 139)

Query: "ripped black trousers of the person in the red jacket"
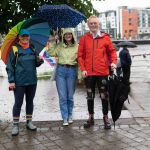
(85, 76, 108, 115)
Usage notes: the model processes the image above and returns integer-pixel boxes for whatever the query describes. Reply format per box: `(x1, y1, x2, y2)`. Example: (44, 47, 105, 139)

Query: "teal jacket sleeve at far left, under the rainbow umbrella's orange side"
(6, 49, 15, 83)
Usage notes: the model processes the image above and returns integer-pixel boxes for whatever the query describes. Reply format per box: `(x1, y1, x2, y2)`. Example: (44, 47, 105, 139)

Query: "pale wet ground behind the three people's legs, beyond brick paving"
(0, 78, 131, 121)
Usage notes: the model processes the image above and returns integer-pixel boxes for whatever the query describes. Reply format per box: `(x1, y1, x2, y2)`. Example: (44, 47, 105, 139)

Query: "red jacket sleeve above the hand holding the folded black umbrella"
(107, 37, 117, 65)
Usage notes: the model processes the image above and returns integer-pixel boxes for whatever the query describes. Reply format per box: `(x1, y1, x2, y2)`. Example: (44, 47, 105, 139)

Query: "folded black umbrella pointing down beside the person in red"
(108, 74, 130, 127)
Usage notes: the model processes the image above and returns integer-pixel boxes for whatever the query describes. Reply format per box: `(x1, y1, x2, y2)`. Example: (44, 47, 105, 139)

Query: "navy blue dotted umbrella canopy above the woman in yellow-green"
(35, 4, 86, 29)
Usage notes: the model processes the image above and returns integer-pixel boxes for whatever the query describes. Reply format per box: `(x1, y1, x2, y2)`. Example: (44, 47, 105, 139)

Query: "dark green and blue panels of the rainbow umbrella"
(21, 18, 50, 53)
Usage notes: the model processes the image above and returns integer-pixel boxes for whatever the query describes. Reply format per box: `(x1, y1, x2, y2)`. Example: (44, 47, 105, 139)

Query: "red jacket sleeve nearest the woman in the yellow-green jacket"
(78, 36, 85, 71)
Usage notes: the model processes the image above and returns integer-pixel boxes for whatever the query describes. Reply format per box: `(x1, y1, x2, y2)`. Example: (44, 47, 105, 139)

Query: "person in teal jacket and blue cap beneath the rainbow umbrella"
(6, 29, 43, 136)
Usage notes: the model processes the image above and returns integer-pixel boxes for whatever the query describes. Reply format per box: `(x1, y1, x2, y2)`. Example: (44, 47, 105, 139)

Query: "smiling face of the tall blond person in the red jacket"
(88, 18, 100, 33)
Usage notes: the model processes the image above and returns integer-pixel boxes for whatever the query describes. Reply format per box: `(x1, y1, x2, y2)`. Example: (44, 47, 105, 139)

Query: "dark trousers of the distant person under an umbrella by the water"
(122, 66, 131, 84)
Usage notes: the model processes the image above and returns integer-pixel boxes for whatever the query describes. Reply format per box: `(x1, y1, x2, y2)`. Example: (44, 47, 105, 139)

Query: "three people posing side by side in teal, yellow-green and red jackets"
(6, 16, 117, 135)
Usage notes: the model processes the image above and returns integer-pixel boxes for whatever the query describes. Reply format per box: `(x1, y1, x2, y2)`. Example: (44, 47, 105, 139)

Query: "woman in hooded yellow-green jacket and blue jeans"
(48, 28, 78, 126)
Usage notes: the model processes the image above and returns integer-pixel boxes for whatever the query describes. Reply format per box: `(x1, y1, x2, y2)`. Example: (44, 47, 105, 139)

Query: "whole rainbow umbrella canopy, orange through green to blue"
(0, 18, 50, 64)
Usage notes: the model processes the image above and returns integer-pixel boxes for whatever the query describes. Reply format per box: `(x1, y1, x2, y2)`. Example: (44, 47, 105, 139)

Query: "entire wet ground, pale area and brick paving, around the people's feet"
(0, 78, 150, 150)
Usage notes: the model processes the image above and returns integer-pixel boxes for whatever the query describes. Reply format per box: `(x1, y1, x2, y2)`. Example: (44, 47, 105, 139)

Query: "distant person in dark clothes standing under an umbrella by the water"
(119, 46, 132, 84)
